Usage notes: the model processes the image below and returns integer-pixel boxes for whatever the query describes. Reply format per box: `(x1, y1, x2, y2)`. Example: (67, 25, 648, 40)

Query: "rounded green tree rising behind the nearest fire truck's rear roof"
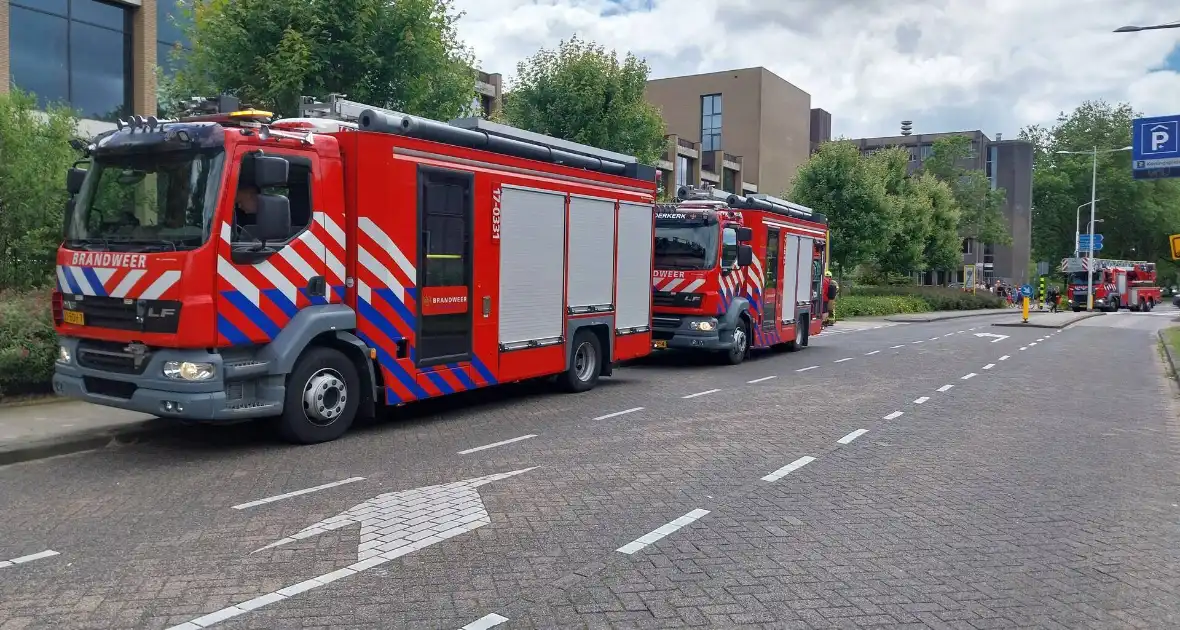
(503, 38, 664, 164)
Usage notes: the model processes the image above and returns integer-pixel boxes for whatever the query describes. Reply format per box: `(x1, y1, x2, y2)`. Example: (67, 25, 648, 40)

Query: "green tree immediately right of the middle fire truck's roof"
(788, 142, 896, 281)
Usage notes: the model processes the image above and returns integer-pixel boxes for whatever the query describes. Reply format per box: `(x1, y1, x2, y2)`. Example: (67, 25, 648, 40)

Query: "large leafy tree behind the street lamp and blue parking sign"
(1021, 100, 1180, 273)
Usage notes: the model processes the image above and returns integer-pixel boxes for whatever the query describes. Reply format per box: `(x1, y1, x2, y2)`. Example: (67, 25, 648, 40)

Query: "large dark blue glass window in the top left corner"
(8, 0, 131, 120)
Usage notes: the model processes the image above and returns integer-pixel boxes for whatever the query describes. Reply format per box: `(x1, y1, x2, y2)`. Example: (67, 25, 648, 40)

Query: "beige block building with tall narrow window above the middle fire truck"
(647, 67, 832, 196)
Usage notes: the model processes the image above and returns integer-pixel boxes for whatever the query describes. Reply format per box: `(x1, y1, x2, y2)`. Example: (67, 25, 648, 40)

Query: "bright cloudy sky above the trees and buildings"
(455, 0, 1180, 137)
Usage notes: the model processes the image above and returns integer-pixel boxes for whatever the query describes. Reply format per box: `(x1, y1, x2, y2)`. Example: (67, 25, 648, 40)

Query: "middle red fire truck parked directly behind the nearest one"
(651, 186, 828, 365)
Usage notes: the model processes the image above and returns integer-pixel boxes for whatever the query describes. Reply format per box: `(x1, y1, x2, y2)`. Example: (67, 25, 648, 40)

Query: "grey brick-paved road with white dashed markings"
(0, 315, 1180, 630)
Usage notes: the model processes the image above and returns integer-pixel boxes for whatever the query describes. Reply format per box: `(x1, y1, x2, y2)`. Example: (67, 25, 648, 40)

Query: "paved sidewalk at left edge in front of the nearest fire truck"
(0, 401, 164, 466)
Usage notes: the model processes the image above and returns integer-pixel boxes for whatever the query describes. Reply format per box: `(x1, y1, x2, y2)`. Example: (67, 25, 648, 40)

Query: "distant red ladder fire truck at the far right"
(1061, 257, 1161, 313)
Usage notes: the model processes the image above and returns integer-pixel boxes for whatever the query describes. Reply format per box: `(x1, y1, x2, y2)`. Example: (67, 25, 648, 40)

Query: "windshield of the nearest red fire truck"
(65, 149, 225, 251)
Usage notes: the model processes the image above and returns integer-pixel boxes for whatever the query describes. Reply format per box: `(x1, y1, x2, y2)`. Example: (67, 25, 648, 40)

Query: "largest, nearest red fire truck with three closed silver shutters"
(53, 97, 656, 442)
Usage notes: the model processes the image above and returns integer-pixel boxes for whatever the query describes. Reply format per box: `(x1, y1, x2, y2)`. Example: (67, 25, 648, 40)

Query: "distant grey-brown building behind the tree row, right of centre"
(852, 131, 1033, 284)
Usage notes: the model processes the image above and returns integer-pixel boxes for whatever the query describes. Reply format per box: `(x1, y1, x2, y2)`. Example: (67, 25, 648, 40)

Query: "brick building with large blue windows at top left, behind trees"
(0, 0, 503, 134)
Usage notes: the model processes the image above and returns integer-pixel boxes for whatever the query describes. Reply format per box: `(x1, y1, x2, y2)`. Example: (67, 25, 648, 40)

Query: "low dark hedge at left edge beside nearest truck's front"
(0, 290, 58, 400)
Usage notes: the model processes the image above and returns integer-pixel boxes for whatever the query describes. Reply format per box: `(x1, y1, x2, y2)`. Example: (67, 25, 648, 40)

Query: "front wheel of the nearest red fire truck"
(276, 347, 360, 444)
